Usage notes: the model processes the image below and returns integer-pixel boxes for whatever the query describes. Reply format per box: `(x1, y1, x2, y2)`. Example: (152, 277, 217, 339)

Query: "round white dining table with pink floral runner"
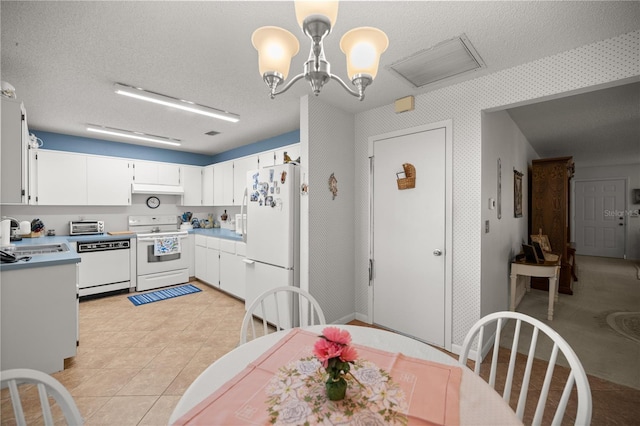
(169, 325, 522, 426)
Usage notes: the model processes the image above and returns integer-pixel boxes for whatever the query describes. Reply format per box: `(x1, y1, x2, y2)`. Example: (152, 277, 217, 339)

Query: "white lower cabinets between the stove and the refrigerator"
(195, 235, 246, 300)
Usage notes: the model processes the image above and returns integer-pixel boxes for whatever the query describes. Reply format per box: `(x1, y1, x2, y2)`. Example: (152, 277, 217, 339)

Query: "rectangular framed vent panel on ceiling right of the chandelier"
(388, 34, 486, 87)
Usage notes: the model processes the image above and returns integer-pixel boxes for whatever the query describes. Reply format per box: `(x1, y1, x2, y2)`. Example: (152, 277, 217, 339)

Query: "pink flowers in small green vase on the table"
(313, 327, 358, 401)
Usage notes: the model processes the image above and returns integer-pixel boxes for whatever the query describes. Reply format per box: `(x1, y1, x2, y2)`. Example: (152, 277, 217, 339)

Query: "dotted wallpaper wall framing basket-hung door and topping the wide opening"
(352, 31, 640, 344)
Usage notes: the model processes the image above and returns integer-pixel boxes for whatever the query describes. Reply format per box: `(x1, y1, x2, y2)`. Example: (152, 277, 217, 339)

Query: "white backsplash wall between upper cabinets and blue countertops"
(0, 194, 240, 235)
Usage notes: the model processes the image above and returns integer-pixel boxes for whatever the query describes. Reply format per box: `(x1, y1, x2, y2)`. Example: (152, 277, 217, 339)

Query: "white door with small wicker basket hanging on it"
(372, 127, 447, 346)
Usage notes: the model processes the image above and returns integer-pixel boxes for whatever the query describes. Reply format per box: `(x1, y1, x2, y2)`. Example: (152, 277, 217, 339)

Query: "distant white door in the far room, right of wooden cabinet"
(575, 179, 627, 258)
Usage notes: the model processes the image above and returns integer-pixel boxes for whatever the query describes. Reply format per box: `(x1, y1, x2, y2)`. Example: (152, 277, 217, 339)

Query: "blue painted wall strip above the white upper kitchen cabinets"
(31, 130, 300, 166)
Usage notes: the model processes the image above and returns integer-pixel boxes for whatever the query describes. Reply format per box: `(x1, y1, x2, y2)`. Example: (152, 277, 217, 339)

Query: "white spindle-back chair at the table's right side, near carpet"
(459, 311, 592, 425)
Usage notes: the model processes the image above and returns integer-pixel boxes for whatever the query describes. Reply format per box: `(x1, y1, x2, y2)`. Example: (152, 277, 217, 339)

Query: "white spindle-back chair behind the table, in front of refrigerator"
(240, 286, 326, 344)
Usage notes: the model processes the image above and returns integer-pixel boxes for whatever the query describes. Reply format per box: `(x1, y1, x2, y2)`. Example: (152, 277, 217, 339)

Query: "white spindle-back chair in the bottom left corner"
(0, 368, 84, 426)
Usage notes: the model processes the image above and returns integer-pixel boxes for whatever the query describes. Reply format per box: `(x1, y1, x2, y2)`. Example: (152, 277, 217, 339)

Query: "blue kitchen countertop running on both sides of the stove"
(0, 228, 242, 271)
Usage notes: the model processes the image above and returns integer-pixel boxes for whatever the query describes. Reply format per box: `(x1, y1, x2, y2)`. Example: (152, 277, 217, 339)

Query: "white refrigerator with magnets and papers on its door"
(244, 164, 300, 326)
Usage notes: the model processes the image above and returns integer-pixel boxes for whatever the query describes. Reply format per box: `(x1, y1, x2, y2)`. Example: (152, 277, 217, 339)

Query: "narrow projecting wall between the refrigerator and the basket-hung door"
(300, 96, 355, 323)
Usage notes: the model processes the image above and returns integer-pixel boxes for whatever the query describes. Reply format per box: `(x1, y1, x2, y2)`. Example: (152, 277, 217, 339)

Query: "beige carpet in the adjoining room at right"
(502, 256, 640, 389)
